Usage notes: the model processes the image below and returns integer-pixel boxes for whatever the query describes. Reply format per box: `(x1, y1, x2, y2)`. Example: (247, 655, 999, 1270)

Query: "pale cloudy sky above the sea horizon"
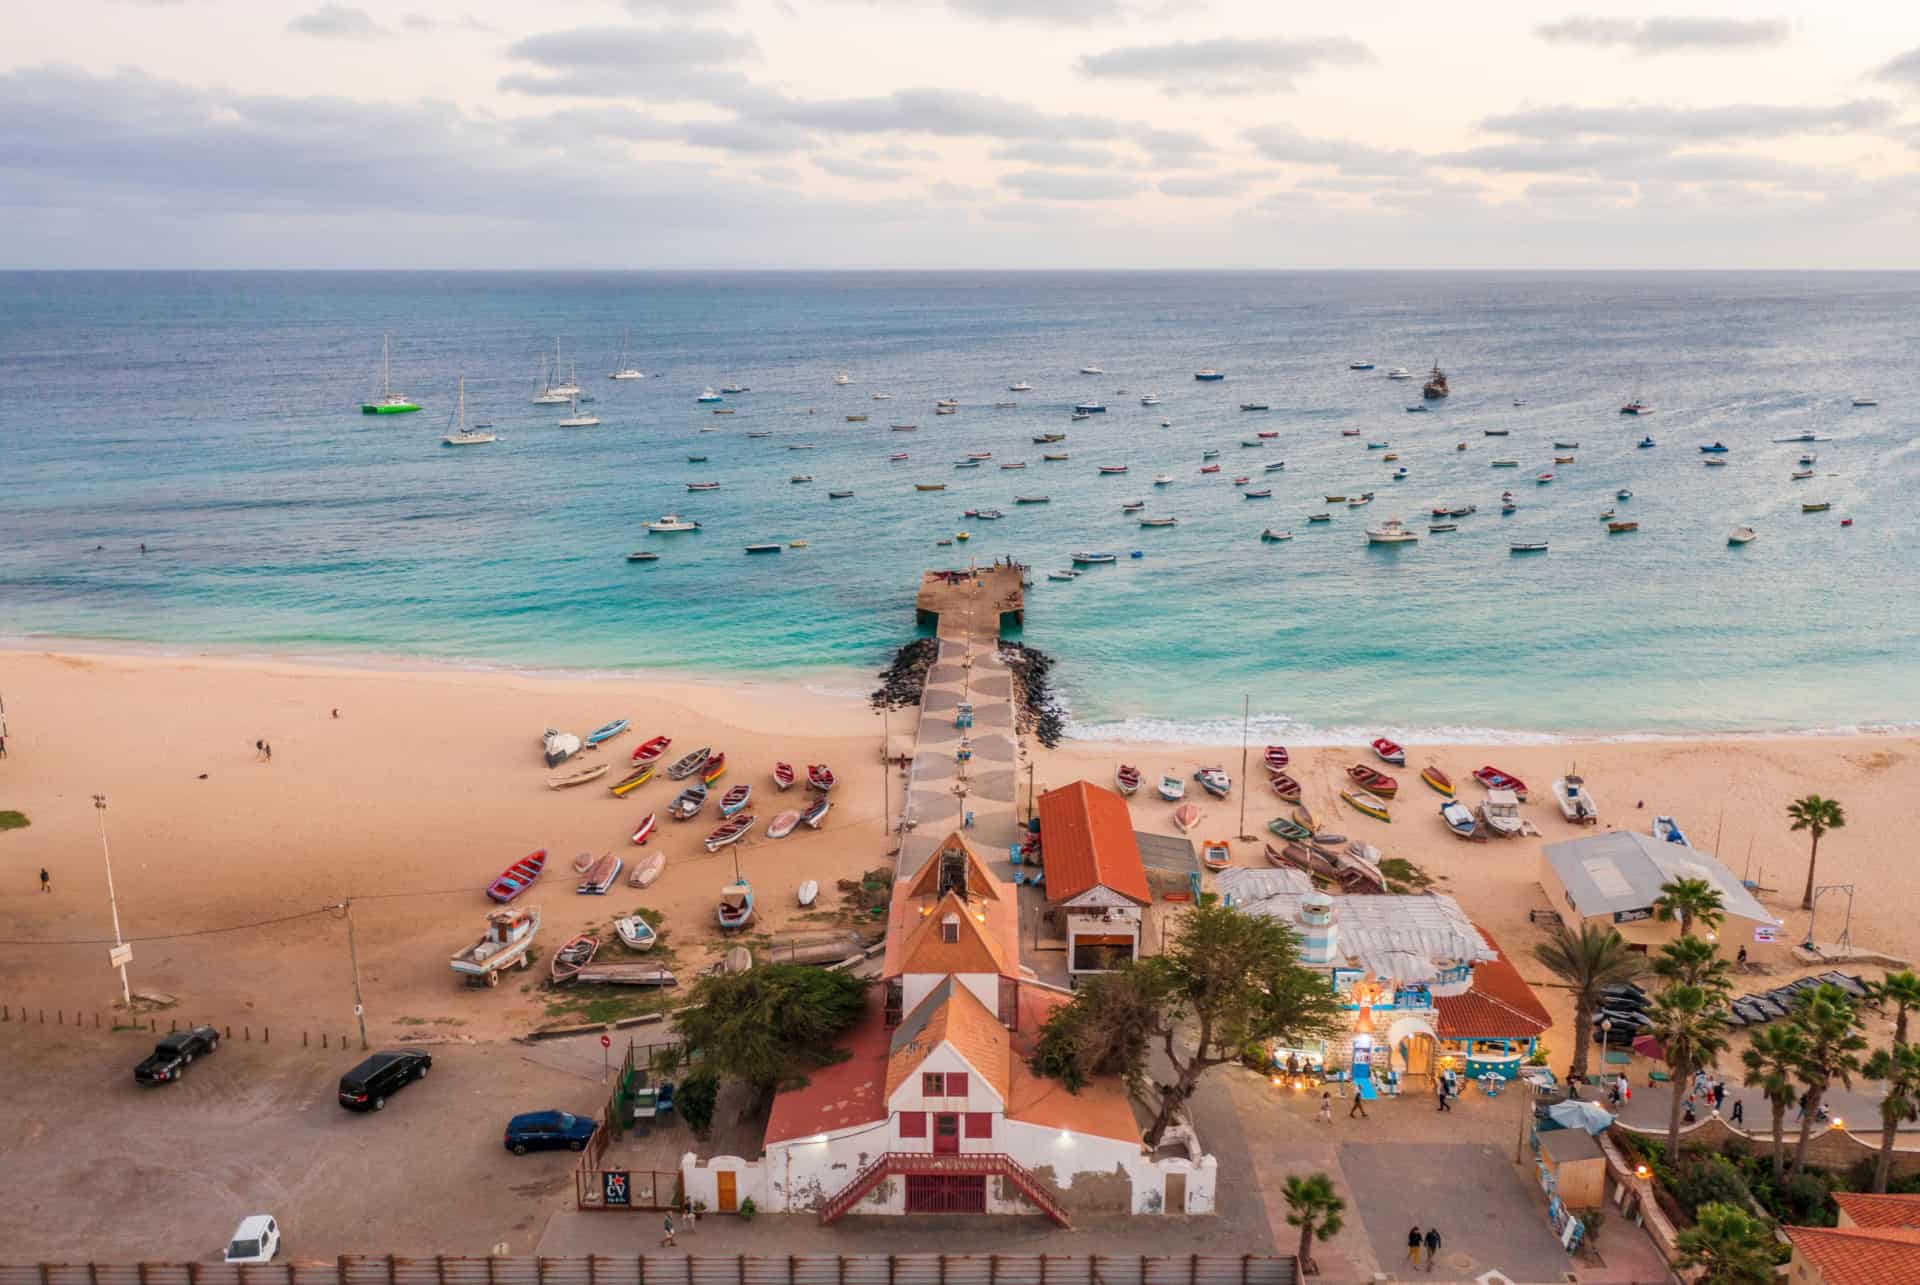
(0, 0, 1920, 269)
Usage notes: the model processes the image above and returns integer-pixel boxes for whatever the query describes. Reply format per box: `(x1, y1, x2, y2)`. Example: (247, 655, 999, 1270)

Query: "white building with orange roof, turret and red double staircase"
(682, 834, 1215, 1224)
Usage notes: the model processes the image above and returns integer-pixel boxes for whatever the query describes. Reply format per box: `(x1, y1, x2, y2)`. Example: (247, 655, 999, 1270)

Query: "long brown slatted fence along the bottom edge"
(0, 1254, 1298, 1285)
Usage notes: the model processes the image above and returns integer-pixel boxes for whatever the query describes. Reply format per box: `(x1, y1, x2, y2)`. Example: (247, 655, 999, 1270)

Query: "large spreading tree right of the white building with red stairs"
(1033, 905, 1346, 1149)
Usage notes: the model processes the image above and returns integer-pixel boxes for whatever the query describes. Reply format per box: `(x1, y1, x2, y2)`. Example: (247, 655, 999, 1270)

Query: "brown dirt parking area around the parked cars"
(0, 1022, 605, 1262)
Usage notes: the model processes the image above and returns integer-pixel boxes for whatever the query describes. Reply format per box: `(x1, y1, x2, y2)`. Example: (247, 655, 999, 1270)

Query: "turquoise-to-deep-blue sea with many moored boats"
(0, 273, 1920, 739)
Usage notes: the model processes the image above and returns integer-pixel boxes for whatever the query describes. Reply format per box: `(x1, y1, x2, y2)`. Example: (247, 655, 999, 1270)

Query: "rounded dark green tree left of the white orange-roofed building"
(676, 964, 866, 1099)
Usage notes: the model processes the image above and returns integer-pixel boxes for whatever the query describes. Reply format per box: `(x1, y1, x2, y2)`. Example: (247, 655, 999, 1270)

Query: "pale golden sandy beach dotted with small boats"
(0, 651, 1920, 1060)
